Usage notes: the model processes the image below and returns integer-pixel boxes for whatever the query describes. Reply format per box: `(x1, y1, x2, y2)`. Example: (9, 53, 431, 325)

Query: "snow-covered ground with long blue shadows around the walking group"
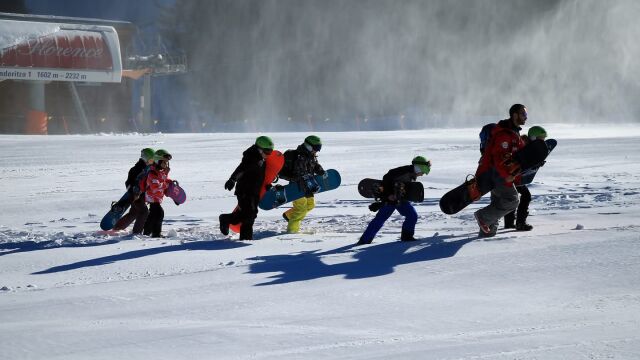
(0, 124, 640, 359)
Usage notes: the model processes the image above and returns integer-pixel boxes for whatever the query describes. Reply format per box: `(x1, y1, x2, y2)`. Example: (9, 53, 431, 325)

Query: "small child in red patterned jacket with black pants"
(140, 149, 172, 238)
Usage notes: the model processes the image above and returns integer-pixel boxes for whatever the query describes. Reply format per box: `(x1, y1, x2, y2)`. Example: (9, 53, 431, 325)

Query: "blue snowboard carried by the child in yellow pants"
(259, 169, 342, 210)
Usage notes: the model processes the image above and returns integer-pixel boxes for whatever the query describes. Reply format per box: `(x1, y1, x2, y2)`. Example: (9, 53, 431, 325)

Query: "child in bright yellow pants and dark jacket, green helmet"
(278, 135, 326, 234)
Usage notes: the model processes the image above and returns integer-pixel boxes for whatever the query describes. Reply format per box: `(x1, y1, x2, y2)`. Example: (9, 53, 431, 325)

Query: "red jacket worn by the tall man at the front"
(476, 119, 525, 186)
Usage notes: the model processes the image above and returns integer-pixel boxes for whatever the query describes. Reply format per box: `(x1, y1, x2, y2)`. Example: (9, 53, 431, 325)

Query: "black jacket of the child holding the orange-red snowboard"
(231, 145, 265, 198)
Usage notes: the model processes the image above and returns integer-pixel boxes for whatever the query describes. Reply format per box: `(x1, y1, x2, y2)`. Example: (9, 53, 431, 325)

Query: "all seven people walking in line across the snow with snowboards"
(107, 104, 547, 245)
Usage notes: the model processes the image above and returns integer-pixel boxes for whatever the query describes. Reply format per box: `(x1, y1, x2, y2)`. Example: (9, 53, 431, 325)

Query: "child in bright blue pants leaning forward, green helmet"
(356, 156, 431, 245)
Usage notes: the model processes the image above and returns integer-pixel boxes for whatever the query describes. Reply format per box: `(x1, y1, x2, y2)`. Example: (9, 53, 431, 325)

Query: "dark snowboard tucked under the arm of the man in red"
(440, 139, 551, 215)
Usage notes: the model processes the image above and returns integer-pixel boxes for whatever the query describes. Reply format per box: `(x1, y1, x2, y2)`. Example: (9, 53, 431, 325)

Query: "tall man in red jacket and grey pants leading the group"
(474, 104, 527, 237)
